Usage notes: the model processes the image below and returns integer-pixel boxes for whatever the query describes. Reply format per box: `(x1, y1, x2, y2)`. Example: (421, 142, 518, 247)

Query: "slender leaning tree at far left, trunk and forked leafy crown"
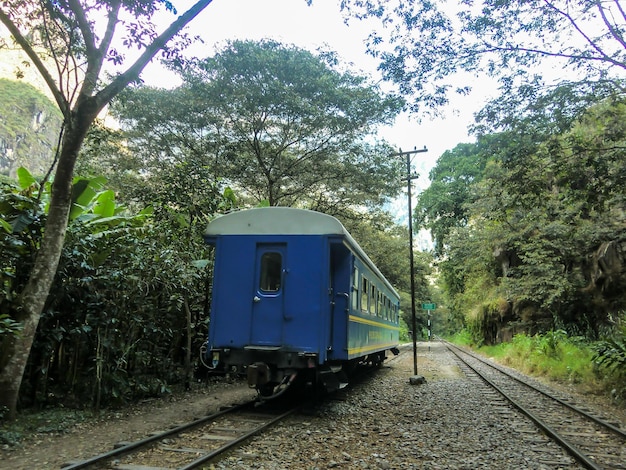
(0, 0, 211, 418)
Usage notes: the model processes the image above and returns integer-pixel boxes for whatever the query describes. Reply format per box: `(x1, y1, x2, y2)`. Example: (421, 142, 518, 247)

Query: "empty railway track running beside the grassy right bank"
(444, 342, 626, 470)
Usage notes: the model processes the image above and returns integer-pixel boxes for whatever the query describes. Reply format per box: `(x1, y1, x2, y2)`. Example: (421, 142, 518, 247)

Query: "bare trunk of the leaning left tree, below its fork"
(0, 108, 97, 419)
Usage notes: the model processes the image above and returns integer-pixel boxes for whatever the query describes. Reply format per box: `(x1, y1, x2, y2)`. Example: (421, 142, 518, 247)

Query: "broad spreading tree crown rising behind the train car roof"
(115, 40, 403, 209)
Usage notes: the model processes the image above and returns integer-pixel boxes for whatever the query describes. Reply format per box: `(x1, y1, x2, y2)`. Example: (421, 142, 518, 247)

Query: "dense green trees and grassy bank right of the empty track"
(416, 87, 626, 400)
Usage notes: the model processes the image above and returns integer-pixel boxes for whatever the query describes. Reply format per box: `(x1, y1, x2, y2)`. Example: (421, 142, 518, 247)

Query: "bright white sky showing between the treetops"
(142, 0, 484, 184)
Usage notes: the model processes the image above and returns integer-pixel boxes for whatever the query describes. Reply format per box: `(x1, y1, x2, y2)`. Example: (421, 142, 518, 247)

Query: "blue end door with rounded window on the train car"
(250, 243, 287, 346)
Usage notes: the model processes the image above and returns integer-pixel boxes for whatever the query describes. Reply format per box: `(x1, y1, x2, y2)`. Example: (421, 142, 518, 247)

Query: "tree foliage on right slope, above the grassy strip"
(420, 86, 626, 343)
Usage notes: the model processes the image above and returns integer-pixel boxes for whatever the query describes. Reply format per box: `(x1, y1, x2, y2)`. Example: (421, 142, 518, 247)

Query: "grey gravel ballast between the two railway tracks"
(212, 342, 604, 470)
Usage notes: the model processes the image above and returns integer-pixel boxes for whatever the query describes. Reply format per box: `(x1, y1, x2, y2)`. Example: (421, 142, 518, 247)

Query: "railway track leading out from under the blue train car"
(62, 401, 301, 470)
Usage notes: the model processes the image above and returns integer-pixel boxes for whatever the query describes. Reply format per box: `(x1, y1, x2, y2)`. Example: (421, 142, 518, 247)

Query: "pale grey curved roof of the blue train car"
(204, 207, 398, 295)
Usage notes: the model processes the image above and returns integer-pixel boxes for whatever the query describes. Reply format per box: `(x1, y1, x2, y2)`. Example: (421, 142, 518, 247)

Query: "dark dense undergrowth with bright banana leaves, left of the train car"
(0, 170, 212, 408)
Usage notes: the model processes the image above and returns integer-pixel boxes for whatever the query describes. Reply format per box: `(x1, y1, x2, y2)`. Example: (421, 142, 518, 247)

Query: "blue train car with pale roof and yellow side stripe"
(205, 207, 400, 396)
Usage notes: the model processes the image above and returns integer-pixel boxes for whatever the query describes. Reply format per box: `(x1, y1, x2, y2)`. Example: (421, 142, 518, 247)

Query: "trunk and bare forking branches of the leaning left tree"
(0, 0, 217, 419)
